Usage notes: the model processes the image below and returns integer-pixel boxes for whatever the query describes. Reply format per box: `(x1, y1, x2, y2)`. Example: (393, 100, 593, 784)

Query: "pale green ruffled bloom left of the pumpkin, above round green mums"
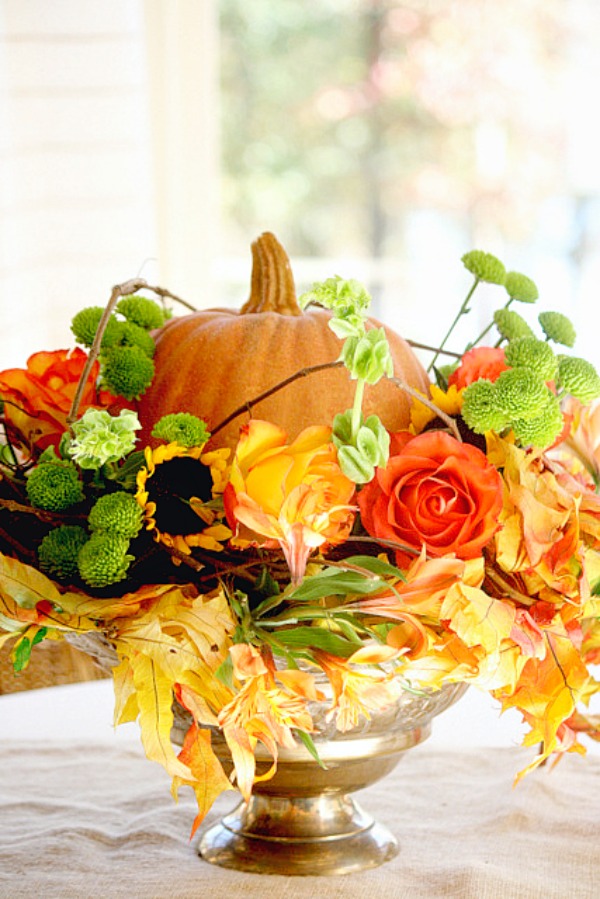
(68, 409, 141, 470)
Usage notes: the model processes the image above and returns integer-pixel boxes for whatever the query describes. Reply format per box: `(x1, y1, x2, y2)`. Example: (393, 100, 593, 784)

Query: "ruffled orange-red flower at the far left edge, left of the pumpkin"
(0, 348, 114, 450)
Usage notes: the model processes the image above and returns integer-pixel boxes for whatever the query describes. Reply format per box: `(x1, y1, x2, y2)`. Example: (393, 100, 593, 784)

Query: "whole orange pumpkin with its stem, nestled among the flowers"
(139, 233, 429, 448)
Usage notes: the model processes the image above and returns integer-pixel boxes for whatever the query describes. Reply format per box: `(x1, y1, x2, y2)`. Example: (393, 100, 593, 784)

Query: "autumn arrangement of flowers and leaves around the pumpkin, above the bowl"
(0, 251, 600, 827)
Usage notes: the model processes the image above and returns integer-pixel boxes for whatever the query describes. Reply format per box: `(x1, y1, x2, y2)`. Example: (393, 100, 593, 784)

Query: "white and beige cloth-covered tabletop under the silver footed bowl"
(0, 682, 600, 899)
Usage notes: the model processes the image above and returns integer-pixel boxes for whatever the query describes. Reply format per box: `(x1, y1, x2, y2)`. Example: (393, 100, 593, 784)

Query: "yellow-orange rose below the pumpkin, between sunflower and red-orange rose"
(224, 419, 355, 583)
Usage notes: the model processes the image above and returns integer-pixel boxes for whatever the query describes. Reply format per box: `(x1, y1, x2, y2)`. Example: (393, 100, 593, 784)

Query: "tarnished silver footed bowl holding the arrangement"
(191, 684, 466, 875)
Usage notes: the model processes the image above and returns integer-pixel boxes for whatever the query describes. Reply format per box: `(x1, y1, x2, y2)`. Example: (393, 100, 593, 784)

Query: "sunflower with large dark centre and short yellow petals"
(135, 443, 231, 555)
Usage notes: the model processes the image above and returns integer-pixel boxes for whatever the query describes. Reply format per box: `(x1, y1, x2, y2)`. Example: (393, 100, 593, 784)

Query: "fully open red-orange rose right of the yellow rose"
(358, 431, 503, 565)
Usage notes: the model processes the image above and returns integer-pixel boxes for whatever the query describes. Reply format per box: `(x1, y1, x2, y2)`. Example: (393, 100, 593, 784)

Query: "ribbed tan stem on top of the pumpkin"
(240, 231, 302, 315)
